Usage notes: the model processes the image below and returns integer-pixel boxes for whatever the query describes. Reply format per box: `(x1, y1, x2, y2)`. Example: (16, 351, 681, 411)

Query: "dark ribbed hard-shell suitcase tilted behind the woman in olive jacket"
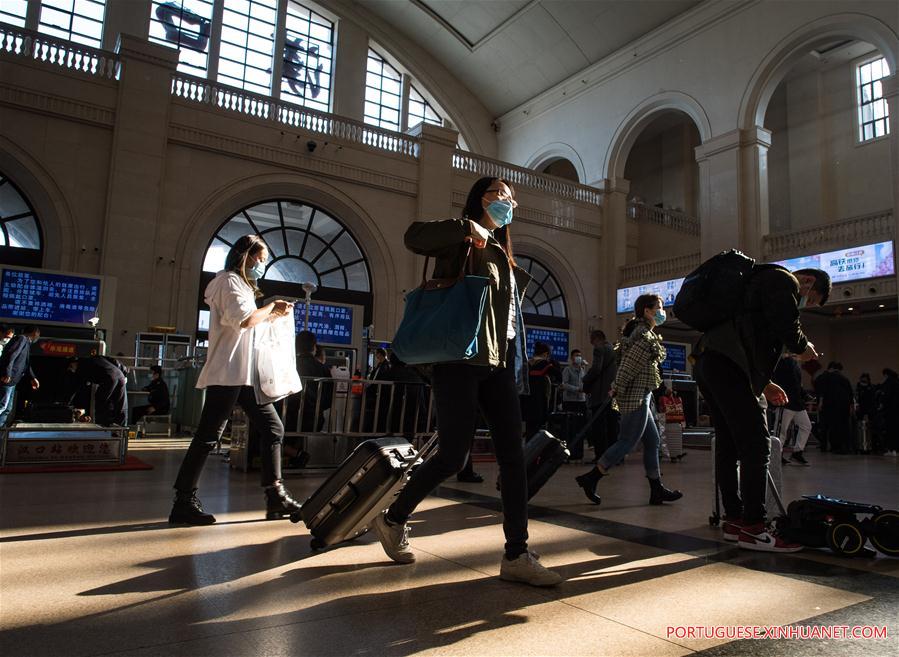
(290, 434, 437, 549)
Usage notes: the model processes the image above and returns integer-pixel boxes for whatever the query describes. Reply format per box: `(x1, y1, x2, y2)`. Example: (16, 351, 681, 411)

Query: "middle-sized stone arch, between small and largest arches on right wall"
(603, 91, 712, 180)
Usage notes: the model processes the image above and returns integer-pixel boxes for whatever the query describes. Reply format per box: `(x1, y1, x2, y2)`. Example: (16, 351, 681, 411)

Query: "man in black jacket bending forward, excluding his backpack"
(693, 265, 831, 552)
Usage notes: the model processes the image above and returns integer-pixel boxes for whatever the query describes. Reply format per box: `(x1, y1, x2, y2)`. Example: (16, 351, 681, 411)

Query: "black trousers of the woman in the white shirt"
(175, 386, 284, 491)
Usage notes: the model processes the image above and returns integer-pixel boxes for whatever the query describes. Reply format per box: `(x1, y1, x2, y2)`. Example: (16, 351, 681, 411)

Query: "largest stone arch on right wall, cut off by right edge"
(738, 14, 899, 130)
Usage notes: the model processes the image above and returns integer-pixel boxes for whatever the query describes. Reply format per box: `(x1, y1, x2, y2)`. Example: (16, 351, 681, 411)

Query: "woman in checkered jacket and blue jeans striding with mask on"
(576, 294, 683, 504)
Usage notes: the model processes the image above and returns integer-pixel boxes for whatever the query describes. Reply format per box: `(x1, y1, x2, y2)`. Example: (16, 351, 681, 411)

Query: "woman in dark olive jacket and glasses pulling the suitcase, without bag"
(374, 178, 562, 586)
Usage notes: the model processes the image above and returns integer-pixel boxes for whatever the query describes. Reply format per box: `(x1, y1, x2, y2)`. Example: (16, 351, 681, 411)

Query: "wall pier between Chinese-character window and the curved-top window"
(331, 21, 368, 121)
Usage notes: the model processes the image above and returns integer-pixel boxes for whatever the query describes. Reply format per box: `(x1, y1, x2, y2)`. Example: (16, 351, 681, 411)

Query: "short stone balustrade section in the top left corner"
(0, 23, 121, 80)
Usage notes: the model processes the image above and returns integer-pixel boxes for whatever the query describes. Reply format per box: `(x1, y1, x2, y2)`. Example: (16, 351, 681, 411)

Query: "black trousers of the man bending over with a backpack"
(693, 351, 771, 524)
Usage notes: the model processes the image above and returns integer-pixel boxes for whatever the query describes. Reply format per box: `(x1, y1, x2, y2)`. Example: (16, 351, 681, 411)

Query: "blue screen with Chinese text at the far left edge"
(0, 269, 100, 324)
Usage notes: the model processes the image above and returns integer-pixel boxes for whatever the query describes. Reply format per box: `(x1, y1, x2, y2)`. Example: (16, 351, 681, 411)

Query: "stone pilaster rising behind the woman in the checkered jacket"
(594, 178, 636, 342)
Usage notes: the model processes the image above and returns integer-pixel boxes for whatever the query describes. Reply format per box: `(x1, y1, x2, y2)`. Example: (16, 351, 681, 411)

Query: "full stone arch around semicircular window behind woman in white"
(172, 173, 402, 336)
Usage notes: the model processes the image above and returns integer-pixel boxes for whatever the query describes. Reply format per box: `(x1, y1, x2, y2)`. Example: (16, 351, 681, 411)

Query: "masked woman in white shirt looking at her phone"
(169, 235, 300, 525)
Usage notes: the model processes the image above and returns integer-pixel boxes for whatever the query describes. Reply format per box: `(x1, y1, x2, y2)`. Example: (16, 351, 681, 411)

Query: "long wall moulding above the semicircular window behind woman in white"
(169, 125, 418, 197)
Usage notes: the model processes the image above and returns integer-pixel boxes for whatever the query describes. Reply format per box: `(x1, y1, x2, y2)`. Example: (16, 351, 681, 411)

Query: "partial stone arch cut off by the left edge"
(0, 136, 79, 271)
